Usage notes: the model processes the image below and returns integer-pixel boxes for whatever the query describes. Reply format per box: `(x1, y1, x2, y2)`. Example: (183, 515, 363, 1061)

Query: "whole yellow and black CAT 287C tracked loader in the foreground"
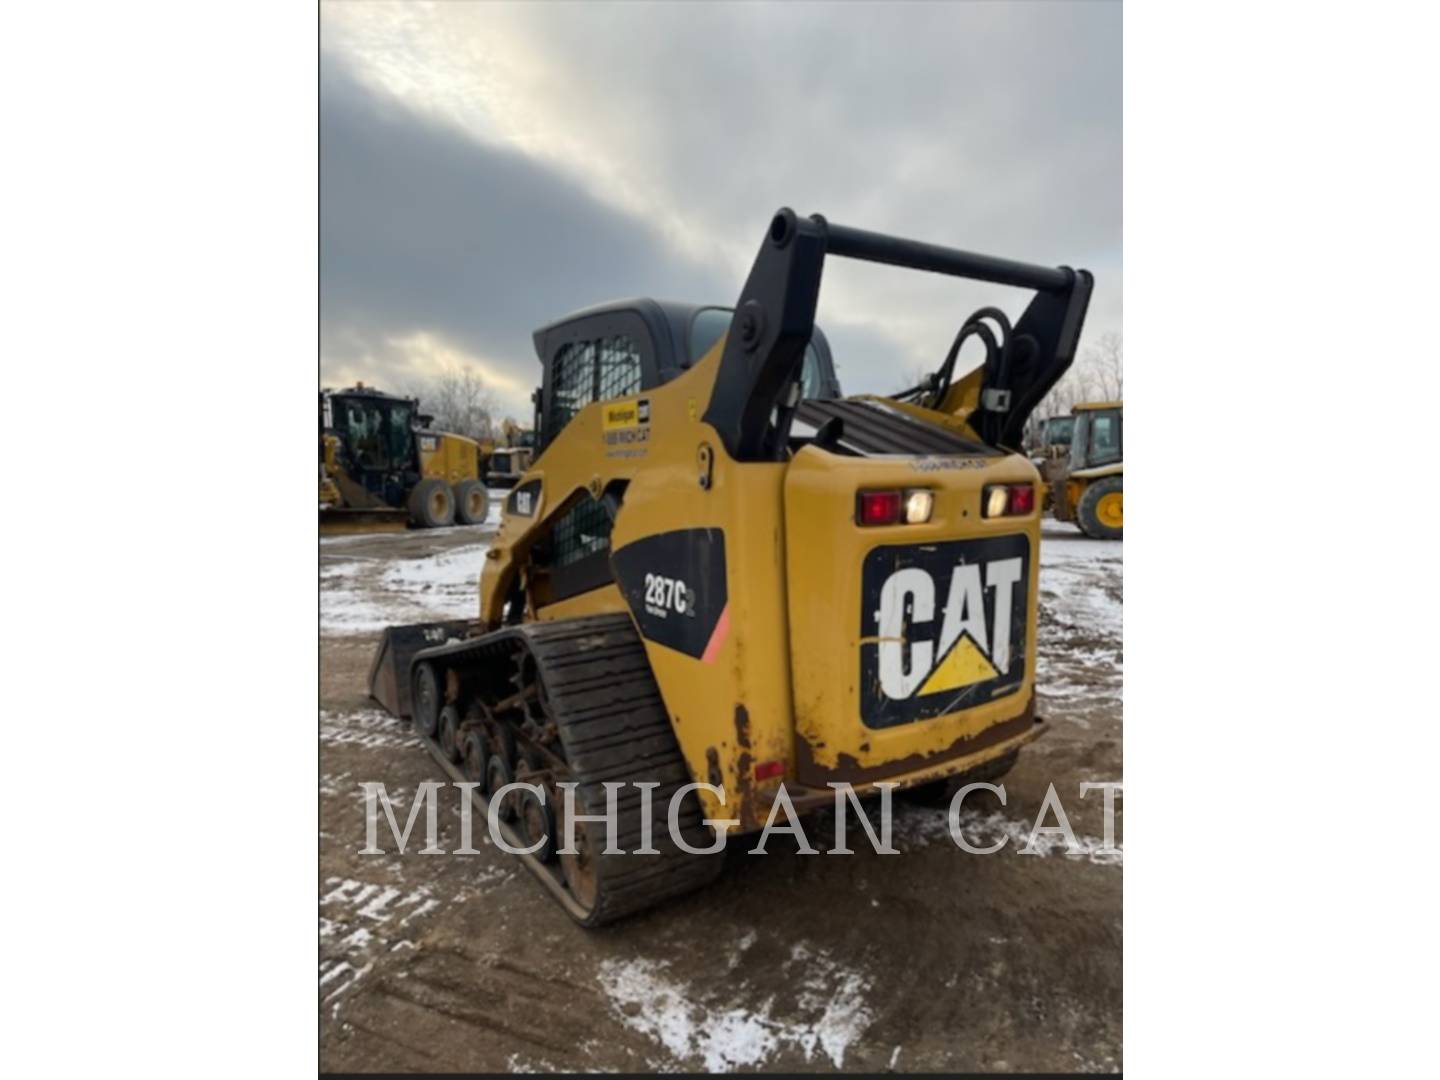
(370, 209, 1092, 926)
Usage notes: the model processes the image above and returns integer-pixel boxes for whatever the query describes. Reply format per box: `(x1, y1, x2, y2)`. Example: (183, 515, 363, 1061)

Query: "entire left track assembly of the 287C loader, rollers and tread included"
(415, 613, 724, 926)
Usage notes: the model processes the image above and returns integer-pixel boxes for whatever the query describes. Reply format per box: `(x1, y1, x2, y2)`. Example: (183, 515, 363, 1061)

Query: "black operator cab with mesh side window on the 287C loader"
(533, 300, 841, 454)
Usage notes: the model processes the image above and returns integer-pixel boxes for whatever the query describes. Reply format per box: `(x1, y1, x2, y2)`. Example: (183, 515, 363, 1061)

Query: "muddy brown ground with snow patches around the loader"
(320, 509, 1123, 1073)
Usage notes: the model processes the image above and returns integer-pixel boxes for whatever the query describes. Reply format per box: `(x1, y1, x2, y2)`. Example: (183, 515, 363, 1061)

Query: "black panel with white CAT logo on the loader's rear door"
(860, 536, 1030, 727)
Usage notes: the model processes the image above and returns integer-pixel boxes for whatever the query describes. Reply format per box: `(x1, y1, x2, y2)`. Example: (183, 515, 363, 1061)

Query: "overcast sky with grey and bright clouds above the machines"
(320, 0, 1122, 419)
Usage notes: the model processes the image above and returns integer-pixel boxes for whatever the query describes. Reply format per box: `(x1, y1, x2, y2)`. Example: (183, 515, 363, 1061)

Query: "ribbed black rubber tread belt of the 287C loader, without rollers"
(483, 613, 724, 926)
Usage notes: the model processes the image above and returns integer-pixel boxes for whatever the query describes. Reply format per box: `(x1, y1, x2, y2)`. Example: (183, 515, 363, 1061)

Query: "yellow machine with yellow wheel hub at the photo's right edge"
(1045, 402, 1125, 540)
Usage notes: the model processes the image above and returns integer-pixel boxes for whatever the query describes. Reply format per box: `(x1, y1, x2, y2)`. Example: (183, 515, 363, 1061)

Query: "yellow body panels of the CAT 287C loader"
(480, 338, 1040, 831)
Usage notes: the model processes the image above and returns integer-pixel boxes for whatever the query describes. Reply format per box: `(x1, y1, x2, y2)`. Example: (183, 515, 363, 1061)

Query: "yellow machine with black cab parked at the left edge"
(320, 383, 490, 533)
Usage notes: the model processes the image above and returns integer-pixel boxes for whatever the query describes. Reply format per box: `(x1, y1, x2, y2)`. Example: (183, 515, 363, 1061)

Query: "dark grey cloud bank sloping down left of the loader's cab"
(320, 56, 723, 409)
